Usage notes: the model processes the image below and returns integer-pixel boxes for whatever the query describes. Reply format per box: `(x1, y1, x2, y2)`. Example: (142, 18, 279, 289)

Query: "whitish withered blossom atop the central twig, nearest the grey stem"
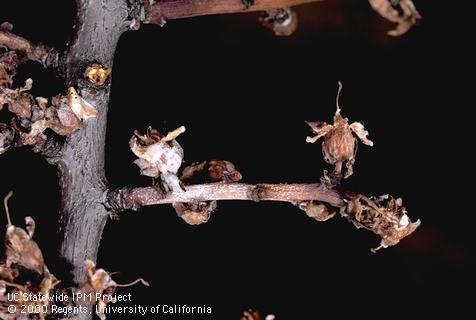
(129, 127, 185, 192)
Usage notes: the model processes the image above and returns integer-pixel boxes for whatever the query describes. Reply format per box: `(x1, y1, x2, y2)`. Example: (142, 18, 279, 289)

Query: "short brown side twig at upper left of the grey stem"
(0, 24, 59, 68)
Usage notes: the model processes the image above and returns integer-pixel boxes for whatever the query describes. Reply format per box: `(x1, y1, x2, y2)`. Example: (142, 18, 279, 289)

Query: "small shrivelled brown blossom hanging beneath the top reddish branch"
(259, 8, 298, 36)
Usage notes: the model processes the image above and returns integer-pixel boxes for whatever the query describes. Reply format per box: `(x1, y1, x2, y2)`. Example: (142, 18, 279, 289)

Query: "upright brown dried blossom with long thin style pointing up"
(306, 81, 373, 179)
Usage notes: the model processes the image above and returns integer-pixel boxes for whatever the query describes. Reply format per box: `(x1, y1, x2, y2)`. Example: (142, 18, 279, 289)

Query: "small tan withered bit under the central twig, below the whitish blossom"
(173, 201, 217, 226)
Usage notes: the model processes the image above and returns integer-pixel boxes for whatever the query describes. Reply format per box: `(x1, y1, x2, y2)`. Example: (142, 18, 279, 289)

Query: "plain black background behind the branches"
(0, 0, 474, 320)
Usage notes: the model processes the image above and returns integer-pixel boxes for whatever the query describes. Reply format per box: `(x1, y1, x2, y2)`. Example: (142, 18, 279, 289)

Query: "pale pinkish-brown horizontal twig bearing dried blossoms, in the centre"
(106, 183, 344, 212)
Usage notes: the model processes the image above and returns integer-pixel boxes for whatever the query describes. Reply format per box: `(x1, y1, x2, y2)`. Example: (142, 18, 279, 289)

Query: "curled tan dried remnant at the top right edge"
(369, 0, 421, 37)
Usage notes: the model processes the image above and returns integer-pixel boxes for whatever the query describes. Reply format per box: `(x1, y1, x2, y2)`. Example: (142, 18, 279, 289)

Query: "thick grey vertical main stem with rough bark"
(56, 0, 128, 290)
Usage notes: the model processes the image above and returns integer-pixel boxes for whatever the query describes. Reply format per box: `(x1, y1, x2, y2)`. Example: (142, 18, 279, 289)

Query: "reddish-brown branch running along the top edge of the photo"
(140, 0, 320, 25)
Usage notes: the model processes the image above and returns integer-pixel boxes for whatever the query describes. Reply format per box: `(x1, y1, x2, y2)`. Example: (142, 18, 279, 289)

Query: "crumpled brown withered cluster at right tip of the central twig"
(341, 194, 421, 252)
